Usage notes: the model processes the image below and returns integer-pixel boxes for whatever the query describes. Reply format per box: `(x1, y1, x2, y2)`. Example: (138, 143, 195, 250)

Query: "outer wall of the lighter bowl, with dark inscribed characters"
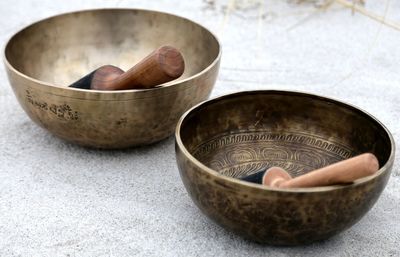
(7, 61, 219, 148)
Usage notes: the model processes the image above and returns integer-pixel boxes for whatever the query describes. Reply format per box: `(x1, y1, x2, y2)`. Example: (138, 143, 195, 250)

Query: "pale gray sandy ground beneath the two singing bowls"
(0, 0, 400, 256)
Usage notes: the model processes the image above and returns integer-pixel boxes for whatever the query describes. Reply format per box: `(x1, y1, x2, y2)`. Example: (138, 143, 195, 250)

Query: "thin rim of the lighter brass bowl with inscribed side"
(2, 7, 222, 94)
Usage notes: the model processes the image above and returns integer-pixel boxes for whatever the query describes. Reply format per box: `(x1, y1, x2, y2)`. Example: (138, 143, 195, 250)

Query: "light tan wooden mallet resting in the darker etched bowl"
(241, 153, 379, 188)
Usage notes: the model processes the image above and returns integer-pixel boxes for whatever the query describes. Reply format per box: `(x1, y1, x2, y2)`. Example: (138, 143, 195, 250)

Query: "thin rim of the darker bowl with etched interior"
(175, 89, 395, 193)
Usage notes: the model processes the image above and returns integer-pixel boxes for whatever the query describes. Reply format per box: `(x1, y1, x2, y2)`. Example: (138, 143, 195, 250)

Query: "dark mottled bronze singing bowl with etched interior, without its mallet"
(176, 91, 395, 245)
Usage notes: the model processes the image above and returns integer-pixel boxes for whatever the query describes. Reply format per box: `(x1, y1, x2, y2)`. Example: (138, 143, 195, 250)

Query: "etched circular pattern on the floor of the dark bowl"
(193, 131, 355, 177)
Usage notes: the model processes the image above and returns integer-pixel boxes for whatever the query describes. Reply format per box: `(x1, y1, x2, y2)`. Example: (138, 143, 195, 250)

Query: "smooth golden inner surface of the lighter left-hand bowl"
(5, 9, 219, 86)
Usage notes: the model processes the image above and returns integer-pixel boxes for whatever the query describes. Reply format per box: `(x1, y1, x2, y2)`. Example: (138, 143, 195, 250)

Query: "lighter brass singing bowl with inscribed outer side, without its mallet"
(4, 9, 221, 148)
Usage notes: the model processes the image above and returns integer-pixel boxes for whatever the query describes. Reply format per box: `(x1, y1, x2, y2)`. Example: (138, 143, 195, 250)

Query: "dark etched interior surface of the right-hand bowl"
(180, 91, 392, 177)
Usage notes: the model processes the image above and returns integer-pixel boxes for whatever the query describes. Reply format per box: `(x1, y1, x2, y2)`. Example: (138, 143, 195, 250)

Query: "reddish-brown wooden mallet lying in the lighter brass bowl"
(69, 46, 185, 90)
